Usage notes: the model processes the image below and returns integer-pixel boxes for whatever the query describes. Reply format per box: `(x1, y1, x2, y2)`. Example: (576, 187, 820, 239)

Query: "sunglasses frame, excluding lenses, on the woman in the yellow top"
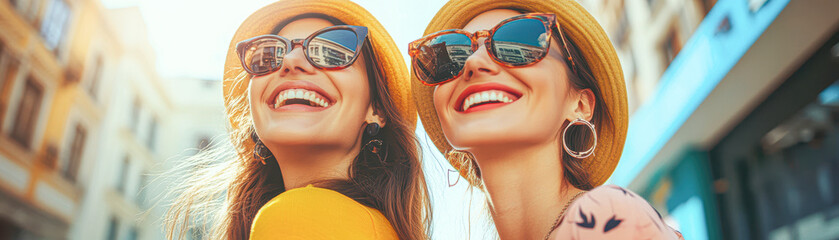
(236, 25, 367, 77)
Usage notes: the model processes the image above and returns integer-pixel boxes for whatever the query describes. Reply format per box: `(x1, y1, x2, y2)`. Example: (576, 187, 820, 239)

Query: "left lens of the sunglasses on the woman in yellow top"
(244, 38, 287, 75)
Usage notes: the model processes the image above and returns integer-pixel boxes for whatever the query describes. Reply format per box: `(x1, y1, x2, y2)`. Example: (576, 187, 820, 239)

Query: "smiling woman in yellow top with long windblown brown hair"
(167, 0, 430, 239)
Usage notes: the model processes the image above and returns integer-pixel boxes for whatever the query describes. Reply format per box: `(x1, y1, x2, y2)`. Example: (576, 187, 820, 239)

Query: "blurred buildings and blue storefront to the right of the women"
(584, 0, 839, 239)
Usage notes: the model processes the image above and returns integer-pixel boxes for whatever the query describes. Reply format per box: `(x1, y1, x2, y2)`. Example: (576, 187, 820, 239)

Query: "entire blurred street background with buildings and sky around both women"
(0, 0, 839, 240)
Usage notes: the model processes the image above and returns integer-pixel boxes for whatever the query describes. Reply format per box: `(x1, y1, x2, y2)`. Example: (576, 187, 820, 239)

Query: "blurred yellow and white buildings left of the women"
(0, 0, 226, 240)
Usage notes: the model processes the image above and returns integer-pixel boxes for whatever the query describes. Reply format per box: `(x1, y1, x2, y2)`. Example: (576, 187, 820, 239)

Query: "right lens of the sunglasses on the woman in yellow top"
(306, 29, 358, 68)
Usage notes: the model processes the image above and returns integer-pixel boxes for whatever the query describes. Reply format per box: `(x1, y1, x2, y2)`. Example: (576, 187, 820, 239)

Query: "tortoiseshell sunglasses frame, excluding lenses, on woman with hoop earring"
(408, 13, 577, 86)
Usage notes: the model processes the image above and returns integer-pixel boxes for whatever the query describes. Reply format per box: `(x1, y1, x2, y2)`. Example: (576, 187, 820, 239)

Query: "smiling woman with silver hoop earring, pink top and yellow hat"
(409, 0, 678, 239)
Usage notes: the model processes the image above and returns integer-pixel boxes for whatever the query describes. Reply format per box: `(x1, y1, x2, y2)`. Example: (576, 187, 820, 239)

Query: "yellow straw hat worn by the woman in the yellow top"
(223, 0, 417, 137)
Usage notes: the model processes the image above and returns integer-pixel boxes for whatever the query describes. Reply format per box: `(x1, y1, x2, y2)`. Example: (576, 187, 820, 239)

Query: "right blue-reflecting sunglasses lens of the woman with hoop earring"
(492, 18, 551, 66)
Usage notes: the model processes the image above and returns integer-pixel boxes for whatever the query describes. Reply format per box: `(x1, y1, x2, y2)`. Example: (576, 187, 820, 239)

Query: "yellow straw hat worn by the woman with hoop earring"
(411, 0, 629, 186)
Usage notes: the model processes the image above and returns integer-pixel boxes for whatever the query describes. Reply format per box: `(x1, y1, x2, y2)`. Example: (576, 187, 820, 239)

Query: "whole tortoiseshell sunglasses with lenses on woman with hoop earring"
(408, 13, 576, 86)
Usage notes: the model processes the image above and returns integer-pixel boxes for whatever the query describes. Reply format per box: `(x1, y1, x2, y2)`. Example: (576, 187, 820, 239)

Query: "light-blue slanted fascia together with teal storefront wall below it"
(609, 0, 789, 239)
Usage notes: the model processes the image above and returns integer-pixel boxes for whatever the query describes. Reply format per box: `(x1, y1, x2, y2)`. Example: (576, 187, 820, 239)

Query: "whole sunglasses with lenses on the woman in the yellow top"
(236, 25, 367, 76)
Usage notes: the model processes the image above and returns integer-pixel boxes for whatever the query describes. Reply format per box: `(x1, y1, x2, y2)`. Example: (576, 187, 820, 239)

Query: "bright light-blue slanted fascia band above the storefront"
(609, 0, 789, 186)
